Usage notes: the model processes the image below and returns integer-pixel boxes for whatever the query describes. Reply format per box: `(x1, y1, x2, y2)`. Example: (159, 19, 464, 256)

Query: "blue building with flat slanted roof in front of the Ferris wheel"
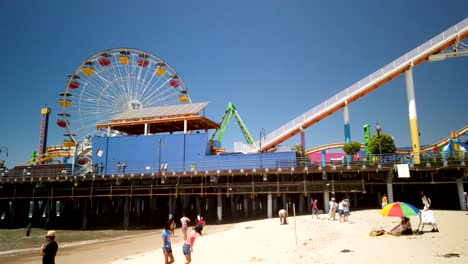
(92, 103, 296, 175)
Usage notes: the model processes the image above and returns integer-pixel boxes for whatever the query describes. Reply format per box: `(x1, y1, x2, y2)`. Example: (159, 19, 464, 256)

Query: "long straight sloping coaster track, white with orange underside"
(256, 18, 468, 151)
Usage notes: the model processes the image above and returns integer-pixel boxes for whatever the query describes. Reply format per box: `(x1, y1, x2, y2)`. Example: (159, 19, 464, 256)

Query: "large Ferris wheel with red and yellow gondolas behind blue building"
(57, 48, 192, 147)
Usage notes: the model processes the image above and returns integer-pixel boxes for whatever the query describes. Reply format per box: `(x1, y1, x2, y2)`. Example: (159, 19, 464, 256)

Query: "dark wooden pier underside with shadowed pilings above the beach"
(0, 160, 468, 229)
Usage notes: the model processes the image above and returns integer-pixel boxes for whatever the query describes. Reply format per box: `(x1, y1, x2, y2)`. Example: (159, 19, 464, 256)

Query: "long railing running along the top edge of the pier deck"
(0, 151, 468, 179)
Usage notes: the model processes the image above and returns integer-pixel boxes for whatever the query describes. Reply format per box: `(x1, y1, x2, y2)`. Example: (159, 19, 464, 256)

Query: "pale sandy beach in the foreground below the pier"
(6, 210, 468, 264)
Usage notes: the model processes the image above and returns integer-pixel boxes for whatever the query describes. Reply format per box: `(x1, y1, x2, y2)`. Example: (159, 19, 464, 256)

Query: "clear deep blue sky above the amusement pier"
(0, 0, 468, 167)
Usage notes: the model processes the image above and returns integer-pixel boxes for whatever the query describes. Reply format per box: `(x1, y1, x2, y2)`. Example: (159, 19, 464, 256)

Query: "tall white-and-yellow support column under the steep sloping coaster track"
(405, 68, 421, 164)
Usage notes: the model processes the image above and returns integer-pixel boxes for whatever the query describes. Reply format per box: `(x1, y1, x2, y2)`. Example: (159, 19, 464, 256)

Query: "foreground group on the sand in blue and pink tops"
(161, 215, 205, 264)
